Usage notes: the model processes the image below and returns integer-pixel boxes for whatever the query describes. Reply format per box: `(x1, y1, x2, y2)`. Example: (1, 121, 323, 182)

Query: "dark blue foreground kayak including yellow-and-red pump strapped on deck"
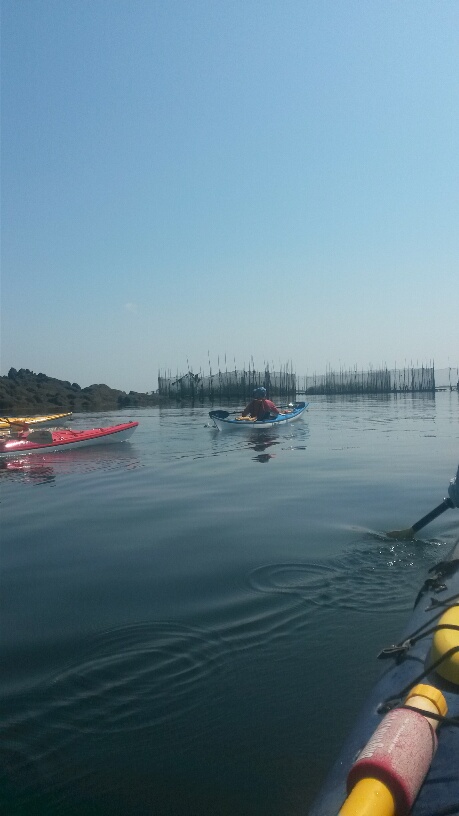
(309, 540, 459, 816)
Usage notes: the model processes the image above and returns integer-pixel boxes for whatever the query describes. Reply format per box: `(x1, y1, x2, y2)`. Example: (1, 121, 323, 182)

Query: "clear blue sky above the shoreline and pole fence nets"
(0, 0, 459, 391)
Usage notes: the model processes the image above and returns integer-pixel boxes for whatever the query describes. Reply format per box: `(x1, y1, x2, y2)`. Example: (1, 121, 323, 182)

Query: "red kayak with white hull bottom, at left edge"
(0, 422, 139, 458)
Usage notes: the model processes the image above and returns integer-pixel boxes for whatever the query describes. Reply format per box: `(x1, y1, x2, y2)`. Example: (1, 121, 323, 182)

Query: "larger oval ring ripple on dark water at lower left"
(53, 623, 228, 734)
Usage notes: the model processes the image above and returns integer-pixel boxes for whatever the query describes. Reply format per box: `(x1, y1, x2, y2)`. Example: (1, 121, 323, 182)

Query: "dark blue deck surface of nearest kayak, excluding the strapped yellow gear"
(309, 540, 459, 816)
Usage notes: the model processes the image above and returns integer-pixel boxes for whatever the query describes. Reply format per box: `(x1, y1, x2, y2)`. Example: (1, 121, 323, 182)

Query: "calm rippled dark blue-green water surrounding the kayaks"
(0, 393, 459, 816)
